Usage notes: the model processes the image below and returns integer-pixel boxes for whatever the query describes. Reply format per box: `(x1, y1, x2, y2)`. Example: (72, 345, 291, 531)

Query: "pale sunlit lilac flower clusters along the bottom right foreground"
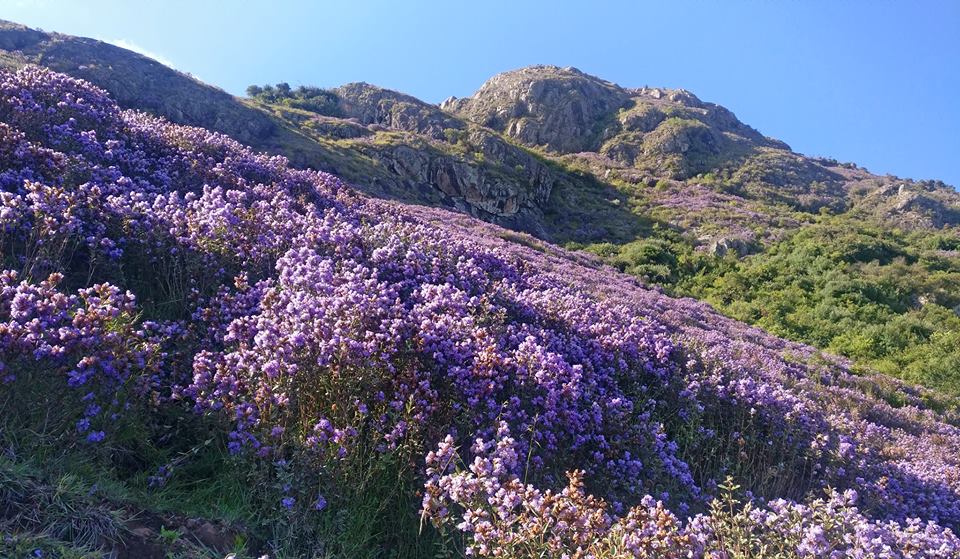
(423, 437, 960, 559)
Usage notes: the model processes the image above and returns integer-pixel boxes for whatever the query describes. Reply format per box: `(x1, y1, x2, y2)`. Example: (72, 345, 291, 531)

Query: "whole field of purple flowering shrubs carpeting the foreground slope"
(0, 67, 960, 557)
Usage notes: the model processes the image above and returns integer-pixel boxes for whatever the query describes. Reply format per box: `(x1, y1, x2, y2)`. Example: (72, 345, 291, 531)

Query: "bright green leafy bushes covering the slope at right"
(680, 217, 960, 393)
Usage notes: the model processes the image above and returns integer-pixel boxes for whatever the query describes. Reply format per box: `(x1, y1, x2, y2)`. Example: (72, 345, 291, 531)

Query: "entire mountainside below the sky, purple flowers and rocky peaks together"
(0, 17, 960, 559)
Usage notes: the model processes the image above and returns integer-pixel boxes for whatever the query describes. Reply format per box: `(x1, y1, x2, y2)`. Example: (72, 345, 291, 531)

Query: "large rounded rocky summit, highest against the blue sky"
(441, 66, 804, 190)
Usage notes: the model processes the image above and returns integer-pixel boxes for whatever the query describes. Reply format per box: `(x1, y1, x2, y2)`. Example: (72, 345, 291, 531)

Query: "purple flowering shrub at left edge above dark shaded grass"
(0, 270, 180, 442)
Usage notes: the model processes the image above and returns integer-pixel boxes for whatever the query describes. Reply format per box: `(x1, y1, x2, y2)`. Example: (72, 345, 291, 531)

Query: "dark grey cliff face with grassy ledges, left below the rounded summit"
(248, 83, 564, 237)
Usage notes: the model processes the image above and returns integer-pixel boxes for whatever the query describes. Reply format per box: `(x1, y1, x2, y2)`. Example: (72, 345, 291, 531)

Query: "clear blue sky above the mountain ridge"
(0, 0, 960, 186)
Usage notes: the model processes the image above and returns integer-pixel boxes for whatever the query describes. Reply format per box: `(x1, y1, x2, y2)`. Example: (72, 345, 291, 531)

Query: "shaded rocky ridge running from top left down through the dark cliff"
(0, 22, 600, 236)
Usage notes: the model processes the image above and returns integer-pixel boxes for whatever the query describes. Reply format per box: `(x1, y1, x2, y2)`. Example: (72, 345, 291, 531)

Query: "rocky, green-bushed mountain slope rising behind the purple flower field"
(0, 20, 960, 393)
